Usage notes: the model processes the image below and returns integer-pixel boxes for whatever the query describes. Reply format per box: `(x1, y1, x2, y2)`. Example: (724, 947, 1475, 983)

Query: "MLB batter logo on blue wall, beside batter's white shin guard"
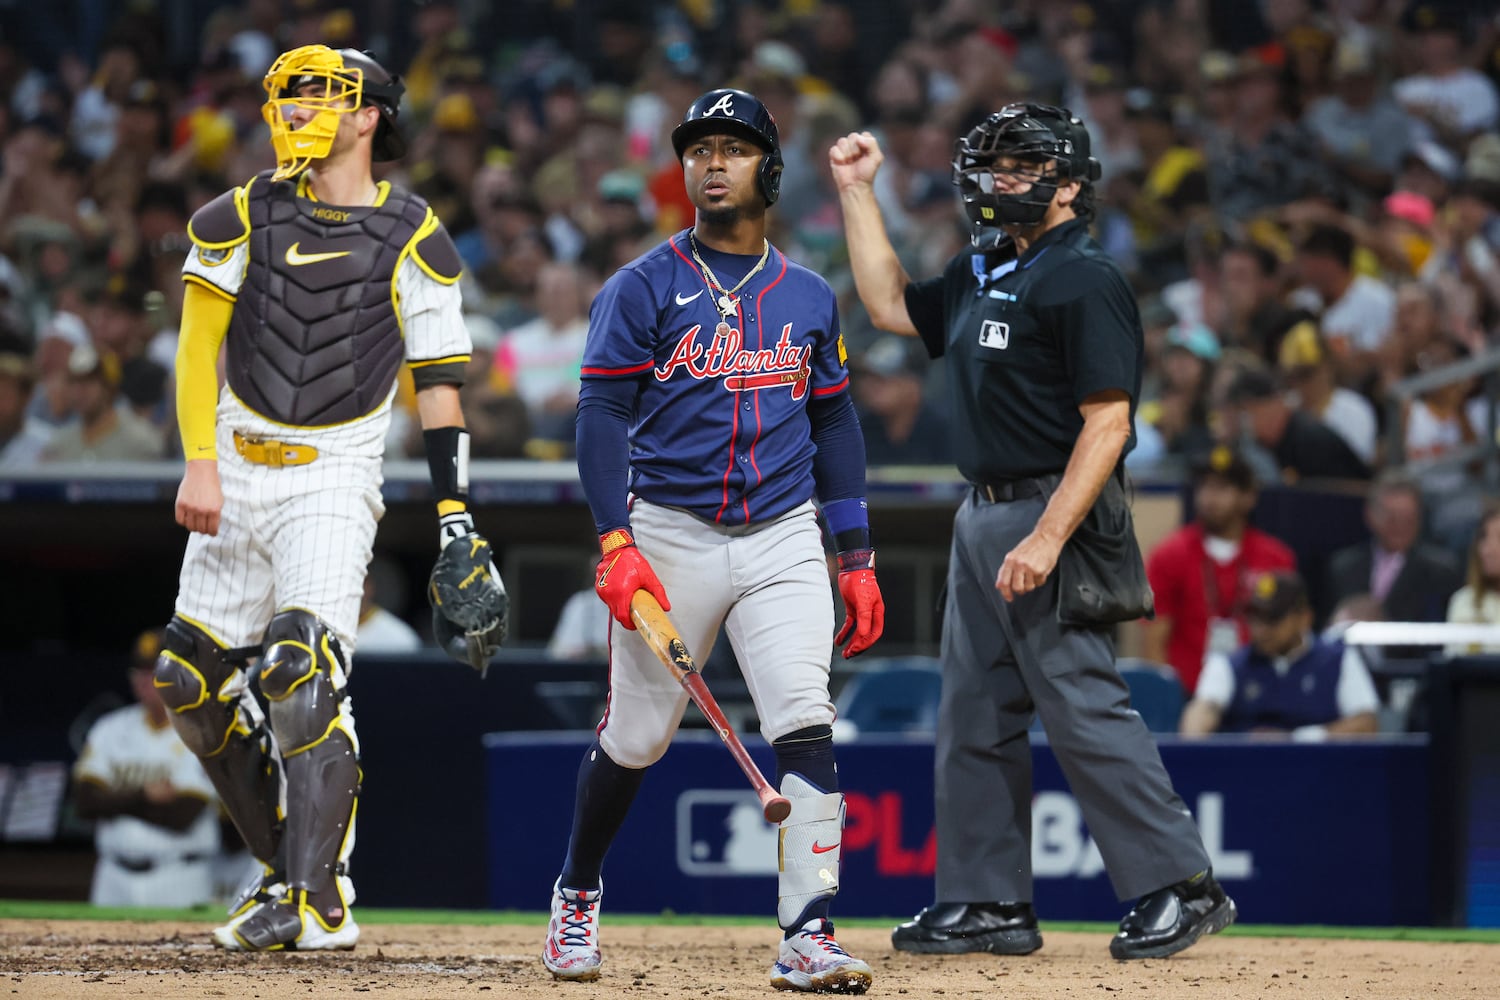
(677, 789, 777, 876)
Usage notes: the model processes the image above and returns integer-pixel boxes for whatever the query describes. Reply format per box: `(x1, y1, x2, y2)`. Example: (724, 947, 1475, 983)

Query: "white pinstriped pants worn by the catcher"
(177, 434, 386, 654)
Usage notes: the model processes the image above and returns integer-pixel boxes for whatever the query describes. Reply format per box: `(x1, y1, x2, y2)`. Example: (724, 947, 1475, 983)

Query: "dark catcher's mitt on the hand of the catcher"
(428, 534, 510, 675)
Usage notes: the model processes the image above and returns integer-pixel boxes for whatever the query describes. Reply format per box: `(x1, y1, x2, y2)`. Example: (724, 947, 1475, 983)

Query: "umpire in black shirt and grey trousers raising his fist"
(828, 105, 1235, 958)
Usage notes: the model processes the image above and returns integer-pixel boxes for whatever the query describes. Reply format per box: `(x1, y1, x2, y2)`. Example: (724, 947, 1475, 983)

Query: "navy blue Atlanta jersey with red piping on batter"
(581, 229, 849, 525)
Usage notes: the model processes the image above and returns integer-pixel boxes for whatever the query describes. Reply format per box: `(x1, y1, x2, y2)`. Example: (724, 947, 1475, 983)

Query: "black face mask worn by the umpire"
(953, 103, 1100, 239)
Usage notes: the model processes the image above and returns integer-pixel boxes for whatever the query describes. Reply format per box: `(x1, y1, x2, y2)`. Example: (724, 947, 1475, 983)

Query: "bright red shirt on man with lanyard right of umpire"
(1146, 522, 1298, 696)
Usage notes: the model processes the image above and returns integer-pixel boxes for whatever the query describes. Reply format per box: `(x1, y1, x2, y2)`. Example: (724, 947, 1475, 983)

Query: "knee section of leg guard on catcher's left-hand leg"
(155, 616, 254, 757)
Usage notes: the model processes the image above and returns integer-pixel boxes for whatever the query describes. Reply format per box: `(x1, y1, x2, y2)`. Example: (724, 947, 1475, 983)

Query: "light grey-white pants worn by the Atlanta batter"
(599, 499, 834, 768)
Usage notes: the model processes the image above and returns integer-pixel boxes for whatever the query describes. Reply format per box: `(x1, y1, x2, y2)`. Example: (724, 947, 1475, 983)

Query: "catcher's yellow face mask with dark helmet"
(261, 45, 407, 180)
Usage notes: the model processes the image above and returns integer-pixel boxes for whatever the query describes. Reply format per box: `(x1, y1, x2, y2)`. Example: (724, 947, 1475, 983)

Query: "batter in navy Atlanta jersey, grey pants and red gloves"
(543, 90, 885, 993)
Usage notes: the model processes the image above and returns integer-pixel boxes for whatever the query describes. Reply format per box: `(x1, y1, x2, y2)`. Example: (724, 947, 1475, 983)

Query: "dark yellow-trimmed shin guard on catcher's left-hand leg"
(155, 616, 285, 864)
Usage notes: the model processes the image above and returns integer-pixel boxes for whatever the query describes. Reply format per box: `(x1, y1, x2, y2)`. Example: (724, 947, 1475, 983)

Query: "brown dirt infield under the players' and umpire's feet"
(0, 921, 1500, 1000)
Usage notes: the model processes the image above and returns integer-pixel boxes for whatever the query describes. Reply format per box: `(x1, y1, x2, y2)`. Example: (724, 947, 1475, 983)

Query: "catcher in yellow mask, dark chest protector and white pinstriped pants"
(156, 45, 506, 951)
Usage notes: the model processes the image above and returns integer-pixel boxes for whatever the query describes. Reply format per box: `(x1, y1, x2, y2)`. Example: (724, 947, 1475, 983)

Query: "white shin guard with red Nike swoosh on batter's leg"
(776, 772, 845, 930)
